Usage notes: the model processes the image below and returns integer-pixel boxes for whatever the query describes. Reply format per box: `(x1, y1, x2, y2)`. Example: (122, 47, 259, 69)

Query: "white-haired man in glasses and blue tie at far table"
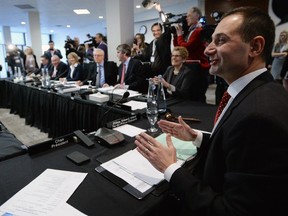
(77, 48, 118, 88)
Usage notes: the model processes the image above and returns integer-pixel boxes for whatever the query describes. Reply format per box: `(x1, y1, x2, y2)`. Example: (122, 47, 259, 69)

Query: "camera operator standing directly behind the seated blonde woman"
(64, 37, 86, 63)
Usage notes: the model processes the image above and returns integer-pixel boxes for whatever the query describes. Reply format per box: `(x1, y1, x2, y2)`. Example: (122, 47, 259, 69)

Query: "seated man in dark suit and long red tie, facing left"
(117, 44, 148, 93)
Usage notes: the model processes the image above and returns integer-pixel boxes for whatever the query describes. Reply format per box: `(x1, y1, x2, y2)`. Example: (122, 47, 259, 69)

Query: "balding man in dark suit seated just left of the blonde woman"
(49, 55, 68, 79)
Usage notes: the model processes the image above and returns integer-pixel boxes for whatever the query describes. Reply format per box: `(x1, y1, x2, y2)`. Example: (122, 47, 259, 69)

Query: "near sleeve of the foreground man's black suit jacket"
(170, 113, 288, 216)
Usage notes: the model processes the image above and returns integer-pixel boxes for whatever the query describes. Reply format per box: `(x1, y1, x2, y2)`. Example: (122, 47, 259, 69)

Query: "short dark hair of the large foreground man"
(222, 7, 275, 61)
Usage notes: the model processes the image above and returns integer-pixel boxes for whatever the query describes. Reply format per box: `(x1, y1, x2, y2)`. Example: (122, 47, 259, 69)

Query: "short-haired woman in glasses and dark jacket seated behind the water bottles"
(153, 46, 205, 102)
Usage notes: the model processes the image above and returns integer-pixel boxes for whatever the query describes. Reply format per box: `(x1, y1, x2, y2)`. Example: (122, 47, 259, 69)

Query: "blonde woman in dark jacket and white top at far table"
(66, 52, 84, 81)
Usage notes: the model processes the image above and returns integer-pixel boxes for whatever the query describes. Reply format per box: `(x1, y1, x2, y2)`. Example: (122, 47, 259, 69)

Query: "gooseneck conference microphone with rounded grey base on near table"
(94, 91, 130, 145)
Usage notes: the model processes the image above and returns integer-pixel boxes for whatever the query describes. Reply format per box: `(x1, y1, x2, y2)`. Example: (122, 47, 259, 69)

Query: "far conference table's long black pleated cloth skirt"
(0, 80, 131, 138)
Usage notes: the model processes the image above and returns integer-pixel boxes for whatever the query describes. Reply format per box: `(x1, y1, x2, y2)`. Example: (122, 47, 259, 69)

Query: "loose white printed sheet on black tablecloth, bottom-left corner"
(0, 169, 87, 216)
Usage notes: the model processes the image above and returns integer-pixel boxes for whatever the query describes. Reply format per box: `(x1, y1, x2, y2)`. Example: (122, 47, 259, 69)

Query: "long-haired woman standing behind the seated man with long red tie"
(131, 33, 148, 62)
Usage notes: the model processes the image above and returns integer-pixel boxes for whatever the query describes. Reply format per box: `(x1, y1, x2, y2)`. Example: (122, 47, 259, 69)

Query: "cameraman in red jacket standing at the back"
(173, 7, 210, 102)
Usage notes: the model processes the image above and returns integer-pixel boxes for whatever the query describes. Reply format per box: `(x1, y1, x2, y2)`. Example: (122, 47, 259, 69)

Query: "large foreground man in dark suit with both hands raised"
(135, 7, 288, 216)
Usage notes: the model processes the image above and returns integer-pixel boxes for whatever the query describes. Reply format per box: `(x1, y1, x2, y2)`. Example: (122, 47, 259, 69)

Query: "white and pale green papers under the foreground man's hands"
(101, 134, 196, 193)
